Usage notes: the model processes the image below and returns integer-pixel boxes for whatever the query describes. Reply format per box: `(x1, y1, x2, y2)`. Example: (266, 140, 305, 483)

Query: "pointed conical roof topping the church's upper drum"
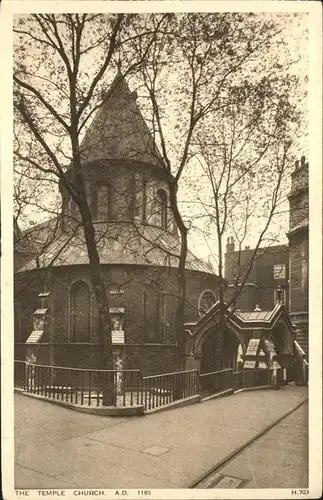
(81, 71, 163, 167)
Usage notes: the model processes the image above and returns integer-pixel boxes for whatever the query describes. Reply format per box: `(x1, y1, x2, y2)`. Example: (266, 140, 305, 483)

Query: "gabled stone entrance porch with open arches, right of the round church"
(185, 303, 305, 383)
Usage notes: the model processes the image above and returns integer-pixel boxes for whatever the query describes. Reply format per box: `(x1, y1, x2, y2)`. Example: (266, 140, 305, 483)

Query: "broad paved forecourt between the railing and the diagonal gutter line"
(15, 386, 307, 489)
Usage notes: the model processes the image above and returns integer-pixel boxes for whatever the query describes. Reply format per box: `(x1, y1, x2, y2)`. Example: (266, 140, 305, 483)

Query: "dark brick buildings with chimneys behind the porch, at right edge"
(225, 156, 309, 353)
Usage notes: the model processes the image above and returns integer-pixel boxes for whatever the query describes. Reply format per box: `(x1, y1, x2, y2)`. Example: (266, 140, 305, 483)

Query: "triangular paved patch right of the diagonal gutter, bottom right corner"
(198, 402, 309, 489)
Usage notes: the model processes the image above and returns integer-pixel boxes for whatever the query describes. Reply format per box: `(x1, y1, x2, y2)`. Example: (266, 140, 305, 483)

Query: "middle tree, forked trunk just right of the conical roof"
(125, 13, 306, 366)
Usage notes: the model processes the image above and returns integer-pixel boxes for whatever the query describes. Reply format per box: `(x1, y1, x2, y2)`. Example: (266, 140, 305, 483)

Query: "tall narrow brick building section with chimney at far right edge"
(287, 156, 309, 353)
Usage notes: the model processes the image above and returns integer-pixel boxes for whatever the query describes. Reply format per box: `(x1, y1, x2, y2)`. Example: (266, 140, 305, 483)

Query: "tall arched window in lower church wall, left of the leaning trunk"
(70, 281, 91, 342)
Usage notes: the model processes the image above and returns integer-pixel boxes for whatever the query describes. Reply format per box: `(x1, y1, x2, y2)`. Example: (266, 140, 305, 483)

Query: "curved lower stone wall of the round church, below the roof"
(15, 265, 217, 374)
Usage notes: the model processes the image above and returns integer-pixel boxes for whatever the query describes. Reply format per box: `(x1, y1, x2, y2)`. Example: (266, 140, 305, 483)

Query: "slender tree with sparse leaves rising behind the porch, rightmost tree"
(187, 65, 304, 356)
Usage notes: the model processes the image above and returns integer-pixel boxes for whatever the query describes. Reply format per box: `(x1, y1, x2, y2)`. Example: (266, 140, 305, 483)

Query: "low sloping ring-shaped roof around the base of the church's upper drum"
(18, 223, 213, 274)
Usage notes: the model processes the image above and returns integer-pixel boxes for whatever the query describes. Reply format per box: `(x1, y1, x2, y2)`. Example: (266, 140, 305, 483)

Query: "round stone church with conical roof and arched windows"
(15, 73, 218, 374)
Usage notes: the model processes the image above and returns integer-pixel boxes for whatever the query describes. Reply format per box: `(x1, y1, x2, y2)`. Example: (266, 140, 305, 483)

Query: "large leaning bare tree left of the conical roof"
(14, 14, 170, 404)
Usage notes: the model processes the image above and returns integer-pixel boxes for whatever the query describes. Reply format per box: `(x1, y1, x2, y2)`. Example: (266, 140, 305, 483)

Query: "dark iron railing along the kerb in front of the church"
(14, 361, 274, 411)
